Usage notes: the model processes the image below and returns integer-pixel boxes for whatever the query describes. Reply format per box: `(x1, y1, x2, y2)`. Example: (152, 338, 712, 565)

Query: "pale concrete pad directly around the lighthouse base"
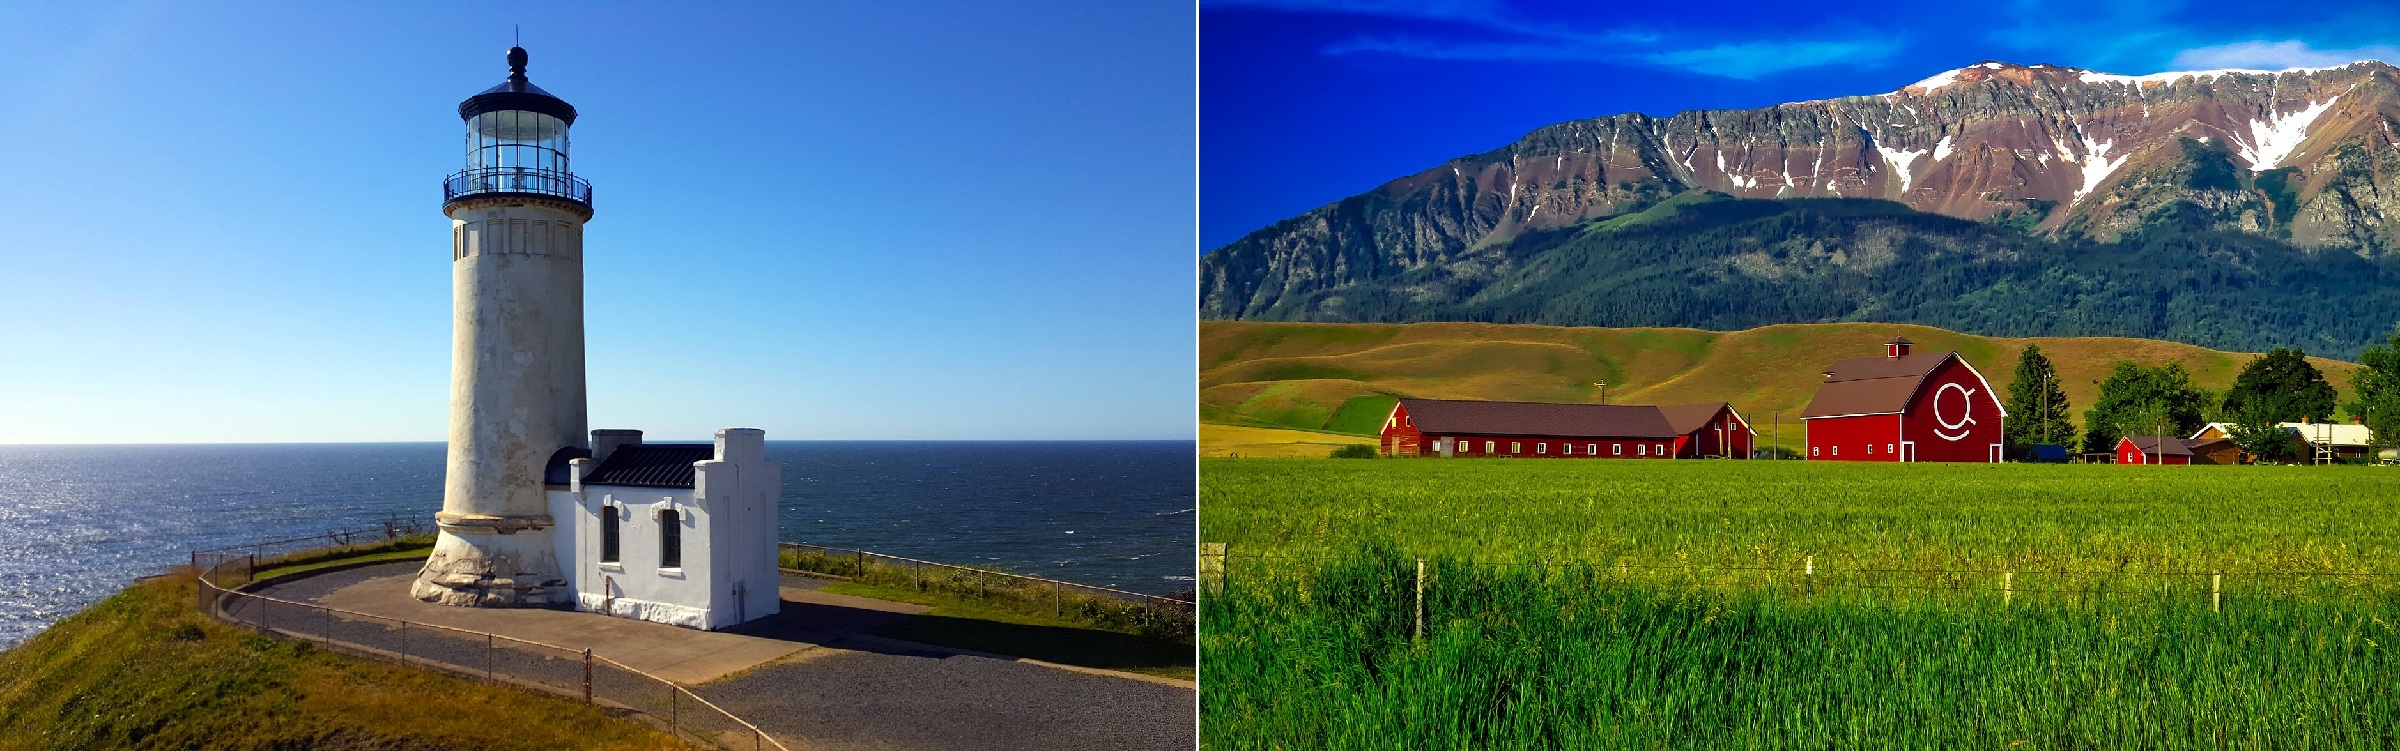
(314, 571, 929, 686)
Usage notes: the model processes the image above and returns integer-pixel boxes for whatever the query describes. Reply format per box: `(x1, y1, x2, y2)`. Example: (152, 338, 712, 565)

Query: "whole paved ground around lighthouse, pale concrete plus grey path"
(250, 561, 1195, 751)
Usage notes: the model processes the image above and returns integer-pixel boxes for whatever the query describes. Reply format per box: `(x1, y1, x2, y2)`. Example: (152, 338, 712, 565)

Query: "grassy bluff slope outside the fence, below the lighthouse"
(0, 566, 691, 751)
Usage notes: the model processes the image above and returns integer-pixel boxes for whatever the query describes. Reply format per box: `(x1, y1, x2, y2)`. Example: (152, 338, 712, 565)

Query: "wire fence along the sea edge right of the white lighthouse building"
(780, 542, 1193, 638)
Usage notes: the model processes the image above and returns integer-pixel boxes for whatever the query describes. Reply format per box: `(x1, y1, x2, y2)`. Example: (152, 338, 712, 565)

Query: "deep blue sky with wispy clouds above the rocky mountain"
(1200, 0, 2400, 252)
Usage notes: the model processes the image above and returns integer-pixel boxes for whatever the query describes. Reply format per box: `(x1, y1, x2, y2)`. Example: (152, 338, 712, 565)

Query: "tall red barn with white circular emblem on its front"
(1800, 336, 2009, 461)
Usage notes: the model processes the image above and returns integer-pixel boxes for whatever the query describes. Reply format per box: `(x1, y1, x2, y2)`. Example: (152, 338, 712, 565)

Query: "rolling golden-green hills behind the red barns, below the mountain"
(1200, 322, 2357, 446)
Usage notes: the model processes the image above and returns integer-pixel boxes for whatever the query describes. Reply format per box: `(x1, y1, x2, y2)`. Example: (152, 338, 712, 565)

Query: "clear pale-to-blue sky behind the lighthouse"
(0, 2, 1195, 444)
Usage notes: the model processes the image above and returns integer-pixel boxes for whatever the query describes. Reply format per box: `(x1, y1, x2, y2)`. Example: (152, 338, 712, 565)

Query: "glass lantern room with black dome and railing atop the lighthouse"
(442, 48, 593, 211)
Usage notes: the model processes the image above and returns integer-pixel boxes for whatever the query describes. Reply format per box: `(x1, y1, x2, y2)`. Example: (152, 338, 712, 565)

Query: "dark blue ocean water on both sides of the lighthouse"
(0, 441, 1195, 645)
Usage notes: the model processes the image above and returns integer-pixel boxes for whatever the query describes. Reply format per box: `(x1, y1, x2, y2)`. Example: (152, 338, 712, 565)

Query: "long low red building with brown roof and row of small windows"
(1382, 398, 1757, 458)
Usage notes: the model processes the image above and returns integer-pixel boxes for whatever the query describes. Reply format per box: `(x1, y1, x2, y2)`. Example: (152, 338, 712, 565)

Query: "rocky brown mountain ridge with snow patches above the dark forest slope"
(1200, 60, 2400, 326)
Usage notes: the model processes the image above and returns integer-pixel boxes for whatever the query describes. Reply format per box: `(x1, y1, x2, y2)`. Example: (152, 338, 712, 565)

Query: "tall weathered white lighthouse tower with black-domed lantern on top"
(410, 48, 593, 607)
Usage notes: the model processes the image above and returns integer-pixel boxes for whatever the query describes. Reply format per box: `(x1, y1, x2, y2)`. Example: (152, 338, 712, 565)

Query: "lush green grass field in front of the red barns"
(1200, 461, 2400, 749)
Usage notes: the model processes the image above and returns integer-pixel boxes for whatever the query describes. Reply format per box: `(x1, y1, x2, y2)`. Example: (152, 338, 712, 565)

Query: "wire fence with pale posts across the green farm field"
(1200, 542, 2400, 612)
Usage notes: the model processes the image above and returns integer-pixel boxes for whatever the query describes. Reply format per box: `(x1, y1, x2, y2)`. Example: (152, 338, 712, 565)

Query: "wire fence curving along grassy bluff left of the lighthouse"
(192, 525, 790, 751)
